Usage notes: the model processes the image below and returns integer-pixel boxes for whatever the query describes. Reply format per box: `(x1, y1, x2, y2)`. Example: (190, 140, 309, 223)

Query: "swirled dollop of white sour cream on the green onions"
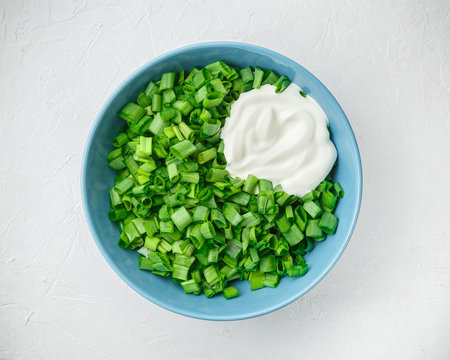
(221, 83, 337, 196)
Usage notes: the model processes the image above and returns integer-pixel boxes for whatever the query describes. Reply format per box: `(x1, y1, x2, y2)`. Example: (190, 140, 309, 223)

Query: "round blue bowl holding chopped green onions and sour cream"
(81, 42, 362, 320)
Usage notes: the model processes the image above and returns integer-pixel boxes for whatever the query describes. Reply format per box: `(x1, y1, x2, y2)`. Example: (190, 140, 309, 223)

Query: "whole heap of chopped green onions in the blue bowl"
(106, 61, 344, 299)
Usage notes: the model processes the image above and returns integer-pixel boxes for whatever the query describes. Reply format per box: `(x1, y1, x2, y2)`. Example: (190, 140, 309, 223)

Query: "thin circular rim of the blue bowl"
(81, 41, 363, 321)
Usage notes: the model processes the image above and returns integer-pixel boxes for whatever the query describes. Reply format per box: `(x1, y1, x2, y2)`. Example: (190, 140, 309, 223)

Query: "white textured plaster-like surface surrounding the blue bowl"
(0, 0, 450, 360)
